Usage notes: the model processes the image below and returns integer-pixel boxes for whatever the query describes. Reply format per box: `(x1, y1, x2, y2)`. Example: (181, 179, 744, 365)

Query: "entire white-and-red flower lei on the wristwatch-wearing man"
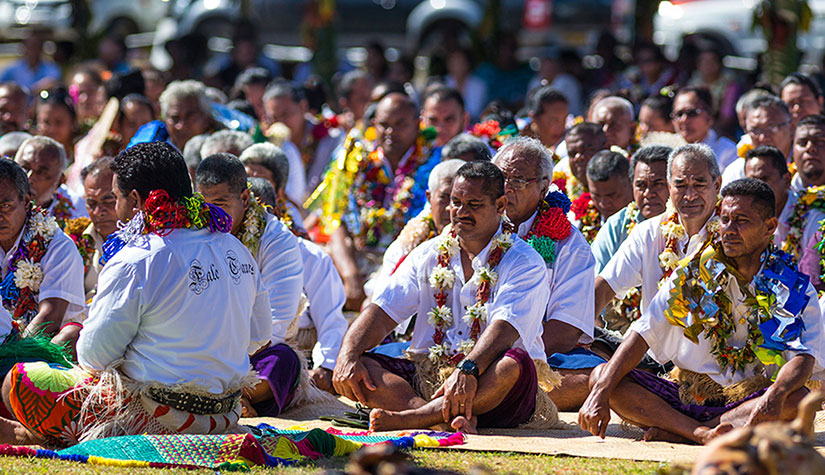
(427, 225, 513, 366)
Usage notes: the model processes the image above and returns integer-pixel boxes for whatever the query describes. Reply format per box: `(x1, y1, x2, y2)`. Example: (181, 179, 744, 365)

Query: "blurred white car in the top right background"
(653, 0, 825, 69)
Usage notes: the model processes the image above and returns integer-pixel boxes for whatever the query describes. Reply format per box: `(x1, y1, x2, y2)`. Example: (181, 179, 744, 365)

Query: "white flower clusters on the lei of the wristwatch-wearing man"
(427, 225, 513, 363)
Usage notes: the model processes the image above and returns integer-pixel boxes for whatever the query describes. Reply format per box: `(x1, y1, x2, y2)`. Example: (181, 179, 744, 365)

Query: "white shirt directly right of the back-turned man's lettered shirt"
(255, 213, 304, 345)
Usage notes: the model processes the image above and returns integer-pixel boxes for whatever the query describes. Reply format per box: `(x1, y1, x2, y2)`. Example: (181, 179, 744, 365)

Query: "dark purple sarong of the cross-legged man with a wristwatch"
(364, 348, 538, 428)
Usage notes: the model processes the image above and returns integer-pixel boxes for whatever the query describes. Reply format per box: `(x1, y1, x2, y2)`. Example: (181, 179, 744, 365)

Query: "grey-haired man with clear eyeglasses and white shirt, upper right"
(722, 95, 793, 186)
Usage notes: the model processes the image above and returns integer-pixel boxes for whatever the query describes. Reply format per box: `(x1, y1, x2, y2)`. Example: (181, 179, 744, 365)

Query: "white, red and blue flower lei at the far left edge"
(0, 205, 60, 327)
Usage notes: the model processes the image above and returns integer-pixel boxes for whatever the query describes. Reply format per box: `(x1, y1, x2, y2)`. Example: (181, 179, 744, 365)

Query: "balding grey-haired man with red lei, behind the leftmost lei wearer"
(14, 135, 86, 228)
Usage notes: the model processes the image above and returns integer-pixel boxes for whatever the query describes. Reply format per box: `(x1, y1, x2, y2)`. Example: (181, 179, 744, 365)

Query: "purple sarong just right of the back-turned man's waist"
(249, 343, 301, 417)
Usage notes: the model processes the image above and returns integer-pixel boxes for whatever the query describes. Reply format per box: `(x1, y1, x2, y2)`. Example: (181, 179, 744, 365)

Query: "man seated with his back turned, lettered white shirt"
(0, 142, 272, 446)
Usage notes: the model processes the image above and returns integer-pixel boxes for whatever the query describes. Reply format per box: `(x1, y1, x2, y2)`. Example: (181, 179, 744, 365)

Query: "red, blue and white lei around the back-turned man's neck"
(100, 190, 232, 265)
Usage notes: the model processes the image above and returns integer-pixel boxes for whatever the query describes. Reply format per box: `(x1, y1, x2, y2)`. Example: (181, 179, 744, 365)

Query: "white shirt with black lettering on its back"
(77, 229, 272, 394)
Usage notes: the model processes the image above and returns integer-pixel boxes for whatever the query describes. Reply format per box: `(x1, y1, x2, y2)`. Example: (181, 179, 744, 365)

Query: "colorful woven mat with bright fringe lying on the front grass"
(0, 424, 464, 470)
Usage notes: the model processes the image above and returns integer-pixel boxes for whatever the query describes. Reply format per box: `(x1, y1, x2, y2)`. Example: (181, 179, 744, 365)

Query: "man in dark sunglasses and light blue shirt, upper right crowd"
(670, 86, 736, 170)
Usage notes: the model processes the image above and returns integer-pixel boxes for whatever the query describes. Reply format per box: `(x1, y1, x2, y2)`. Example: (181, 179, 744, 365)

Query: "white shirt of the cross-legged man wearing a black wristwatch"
(373, 227, 548, 360)
